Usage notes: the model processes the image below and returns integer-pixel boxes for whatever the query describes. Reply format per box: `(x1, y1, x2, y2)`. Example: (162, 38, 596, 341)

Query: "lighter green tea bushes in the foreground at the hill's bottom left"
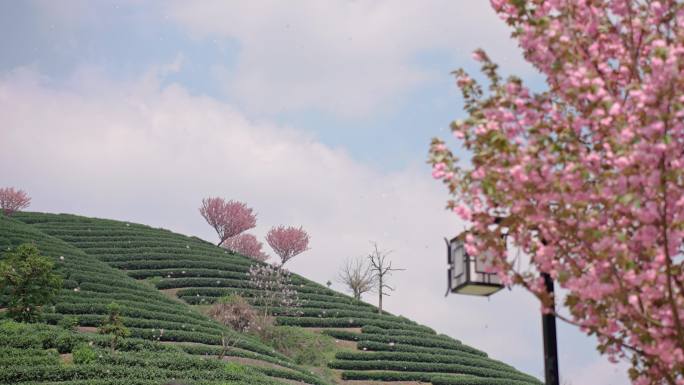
(0, 321, 328, 385)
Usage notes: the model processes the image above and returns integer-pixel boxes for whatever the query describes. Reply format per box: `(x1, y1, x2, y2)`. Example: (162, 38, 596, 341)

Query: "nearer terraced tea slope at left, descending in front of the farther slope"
(0, 216, 324, 384)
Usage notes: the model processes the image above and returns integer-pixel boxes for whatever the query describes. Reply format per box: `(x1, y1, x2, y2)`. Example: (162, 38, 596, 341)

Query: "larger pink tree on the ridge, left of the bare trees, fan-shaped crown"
(199, 198, 256, 246)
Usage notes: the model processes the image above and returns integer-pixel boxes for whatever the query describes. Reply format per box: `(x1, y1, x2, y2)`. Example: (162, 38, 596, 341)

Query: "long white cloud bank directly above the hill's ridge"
(0, 67, 628, 384)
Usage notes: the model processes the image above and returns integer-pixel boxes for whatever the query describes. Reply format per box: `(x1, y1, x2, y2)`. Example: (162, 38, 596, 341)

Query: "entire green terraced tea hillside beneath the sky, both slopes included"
(0, 213, 540, 385)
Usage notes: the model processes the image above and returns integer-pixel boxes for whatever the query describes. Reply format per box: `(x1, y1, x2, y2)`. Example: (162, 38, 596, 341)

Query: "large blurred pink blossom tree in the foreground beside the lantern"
(430, 0, 684, 385)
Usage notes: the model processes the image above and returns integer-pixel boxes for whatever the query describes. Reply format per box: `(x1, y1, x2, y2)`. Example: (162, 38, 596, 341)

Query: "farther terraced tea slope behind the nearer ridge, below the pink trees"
(5, 213, 538, 385)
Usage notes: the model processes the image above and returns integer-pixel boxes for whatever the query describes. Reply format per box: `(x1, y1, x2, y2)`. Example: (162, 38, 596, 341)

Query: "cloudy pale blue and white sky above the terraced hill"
(0, 0, 629, 385)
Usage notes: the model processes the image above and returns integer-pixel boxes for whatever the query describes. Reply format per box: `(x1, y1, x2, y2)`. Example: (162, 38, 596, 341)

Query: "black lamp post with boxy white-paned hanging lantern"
(444, 232, 559, 385)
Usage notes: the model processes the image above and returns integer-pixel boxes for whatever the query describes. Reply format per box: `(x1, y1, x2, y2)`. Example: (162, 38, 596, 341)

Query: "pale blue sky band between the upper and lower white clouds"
(0, 1, 530, 170)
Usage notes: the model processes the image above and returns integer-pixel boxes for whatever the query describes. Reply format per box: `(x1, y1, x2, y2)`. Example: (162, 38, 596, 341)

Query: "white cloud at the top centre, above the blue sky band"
(167, 0, 529, 116)
